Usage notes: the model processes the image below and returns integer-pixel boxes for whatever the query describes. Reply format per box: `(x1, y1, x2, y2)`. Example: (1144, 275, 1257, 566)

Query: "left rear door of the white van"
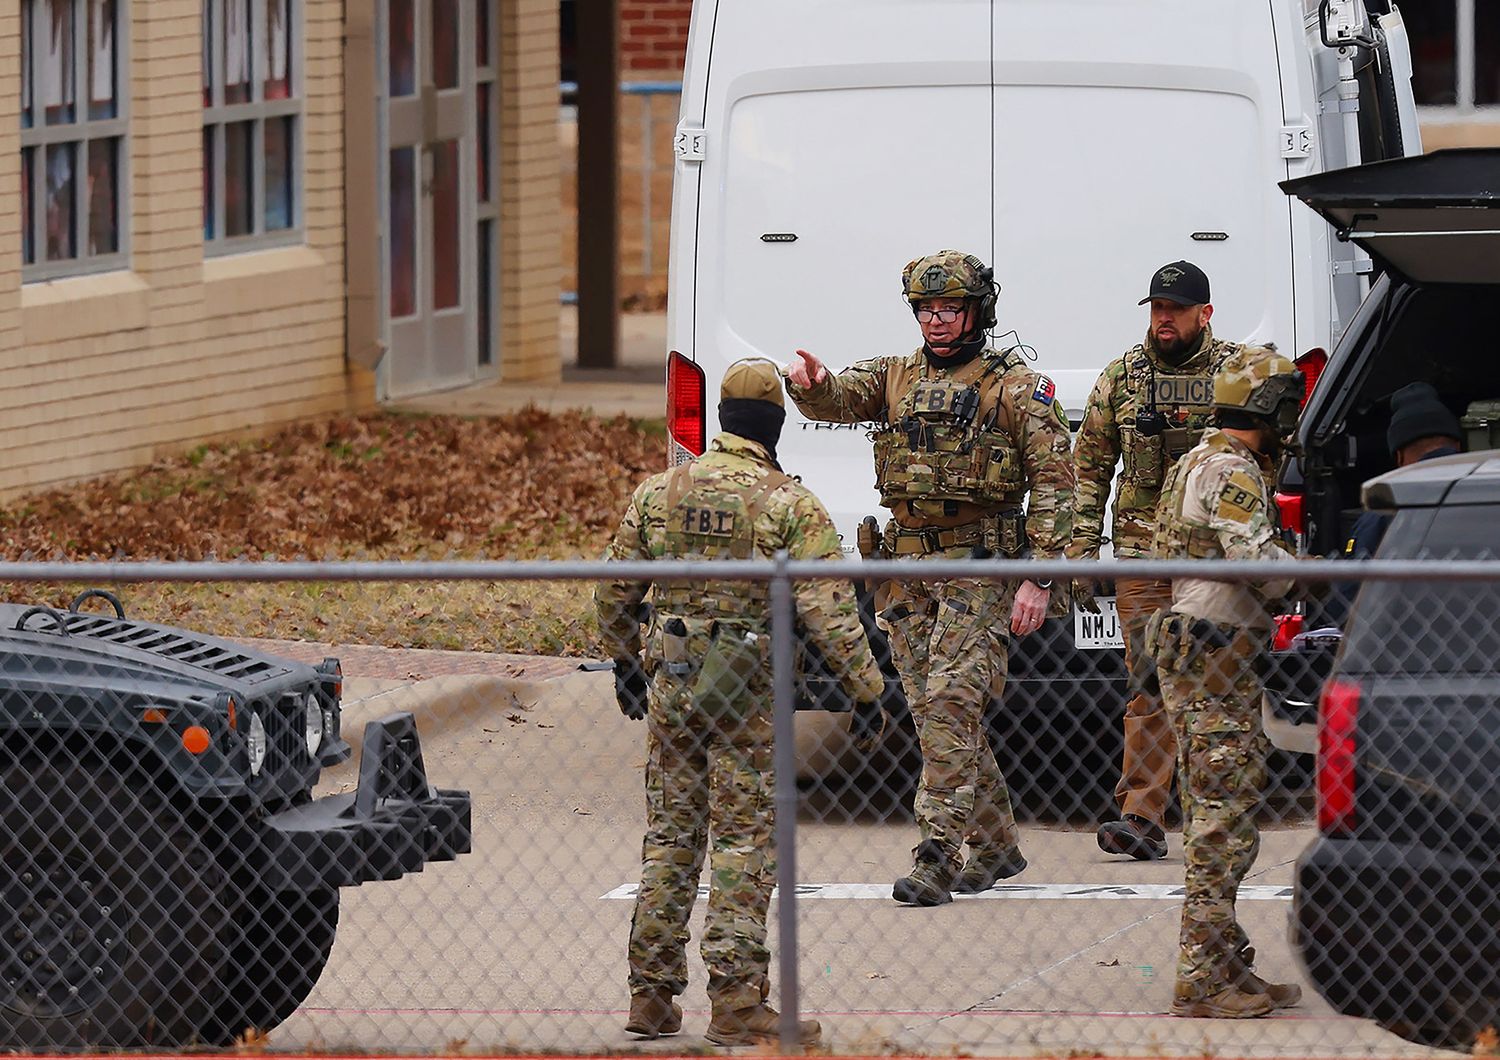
(690, 0, 993, 547)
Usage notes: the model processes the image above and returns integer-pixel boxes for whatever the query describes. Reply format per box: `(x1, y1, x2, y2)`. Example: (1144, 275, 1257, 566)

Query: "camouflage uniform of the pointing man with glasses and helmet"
(788, 349, 1073, 870)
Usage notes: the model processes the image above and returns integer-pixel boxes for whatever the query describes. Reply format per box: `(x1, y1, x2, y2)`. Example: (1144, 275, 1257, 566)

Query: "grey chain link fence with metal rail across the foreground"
(0, 561, 1500, 1056)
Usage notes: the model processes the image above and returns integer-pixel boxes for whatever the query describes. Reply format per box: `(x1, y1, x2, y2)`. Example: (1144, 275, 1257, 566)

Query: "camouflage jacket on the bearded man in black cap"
(1068, 325, 1239, 559)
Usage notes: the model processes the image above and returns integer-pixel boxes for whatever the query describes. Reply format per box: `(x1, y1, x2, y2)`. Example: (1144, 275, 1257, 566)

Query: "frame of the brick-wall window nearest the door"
(198, 0, 308, 258)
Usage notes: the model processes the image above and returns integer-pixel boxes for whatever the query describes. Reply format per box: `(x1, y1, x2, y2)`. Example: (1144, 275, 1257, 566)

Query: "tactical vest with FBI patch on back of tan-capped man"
(653, 463, 792, 624)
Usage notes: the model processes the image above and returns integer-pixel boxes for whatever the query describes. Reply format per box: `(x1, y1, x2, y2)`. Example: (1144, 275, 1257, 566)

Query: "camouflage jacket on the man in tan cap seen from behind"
(594, 432, 885, 700)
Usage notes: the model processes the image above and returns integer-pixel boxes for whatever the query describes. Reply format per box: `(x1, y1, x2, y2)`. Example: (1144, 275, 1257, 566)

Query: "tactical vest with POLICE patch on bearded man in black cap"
(1118, 339, 1239, 510)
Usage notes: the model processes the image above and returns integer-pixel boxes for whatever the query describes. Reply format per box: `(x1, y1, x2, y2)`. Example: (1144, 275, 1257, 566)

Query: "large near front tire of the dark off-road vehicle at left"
(0, 758, 227, 1051)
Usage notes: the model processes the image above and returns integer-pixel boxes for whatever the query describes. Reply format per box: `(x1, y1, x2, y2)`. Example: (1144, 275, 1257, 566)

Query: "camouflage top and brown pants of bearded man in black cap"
(1068, 325, 1239, 826)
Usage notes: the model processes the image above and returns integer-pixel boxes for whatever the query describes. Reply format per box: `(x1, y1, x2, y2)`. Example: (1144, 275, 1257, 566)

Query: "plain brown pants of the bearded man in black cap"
(1115, 579, 1178, 825)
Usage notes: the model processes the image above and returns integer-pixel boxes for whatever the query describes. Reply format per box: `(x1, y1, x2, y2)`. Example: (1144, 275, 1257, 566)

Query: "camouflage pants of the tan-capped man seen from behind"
(629, 662, 776, 1008)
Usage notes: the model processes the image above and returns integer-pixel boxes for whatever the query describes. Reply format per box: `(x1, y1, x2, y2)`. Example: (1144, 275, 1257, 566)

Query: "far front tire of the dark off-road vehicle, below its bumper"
(203, 888, 339, 1045)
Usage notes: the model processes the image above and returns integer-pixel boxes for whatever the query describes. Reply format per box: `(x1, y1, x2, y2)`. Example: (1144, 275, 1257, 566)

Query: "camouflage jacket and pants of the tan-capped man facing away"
(594, 433, 884, 1009)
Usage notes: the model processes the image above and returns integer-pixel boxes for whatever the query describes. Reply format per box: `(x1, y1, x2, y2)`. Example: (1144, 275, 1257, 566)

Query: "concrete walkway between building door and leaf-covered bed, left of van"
(392, 306, 668, 420)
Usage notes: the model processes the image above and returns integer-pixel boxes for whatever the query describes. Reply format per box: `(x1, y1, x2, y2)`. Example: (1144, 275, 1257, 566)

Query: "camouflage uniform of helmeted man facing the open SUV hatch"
(1146, 429, 1292, 997)
